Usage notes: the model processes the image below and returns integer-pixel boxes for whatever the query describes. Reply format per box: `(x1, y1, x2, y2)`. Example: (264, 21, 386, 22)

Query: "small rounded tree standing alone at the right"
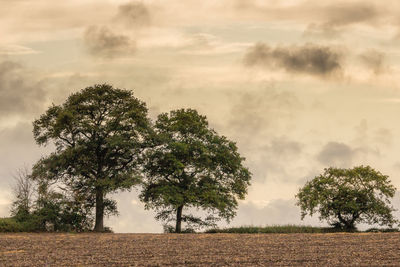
(296, 166, 396, 231)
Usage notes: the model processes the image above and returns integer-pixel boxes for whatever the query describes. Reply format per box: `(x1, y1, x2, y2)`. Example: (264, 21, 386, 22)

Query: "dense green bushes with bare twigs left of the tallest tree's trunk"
(9, 169, 93, 232)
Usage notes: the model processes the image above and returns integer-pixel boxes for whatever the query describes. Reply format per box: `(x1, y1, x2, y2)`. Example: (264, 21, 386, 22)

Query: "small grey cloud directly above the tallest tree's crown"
(84, 26, 136, 58)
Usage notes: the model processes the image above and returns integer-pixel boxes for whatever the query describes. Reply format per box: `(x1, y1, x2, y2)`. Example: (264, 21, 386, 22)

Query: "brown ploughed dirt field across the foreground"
(0, 233, 400, 266)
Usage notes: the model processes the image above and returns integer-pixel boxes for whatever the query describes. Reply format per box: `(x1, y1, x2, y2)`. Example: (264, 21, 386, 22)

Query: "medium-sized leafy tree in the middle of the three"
(140, 109, 251, 233)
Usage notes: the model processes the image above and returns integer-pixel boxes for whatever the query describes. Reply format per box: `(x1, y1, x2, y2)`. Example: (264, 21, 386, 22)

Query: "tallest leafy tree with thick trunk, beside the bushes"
(32, 84, 150, 231)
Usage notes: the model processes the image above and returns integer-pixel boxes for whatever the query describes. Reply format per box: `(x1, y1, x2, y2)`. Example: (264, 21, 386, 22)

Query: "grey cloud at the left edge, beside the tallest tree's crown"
(0, 61, 46, 119)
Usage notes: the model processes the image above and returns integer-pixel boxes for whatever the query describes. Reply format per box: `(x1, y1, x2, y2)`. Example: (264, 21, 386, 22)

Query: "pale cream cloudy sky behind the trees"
(0, 0, 400, 232)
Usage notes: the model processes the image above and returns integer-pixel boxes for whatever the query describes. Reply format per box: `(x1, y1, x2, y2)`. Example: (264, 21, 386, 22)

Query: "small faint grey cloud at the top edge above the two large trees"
(115, 2, 151, 27)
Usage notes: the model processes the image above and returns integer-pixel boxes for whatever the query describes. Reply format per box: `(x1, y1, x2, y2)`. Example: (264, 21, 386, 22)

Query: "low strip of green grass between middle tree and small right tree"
(206, 225, 348, 234)
